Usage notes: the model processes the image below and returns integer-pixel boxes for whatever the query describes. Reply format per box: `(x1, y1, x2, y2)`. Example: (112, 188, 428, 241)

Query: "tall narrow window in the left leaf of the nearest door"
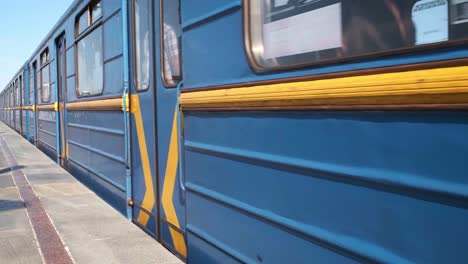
(133, 0, 151, 91)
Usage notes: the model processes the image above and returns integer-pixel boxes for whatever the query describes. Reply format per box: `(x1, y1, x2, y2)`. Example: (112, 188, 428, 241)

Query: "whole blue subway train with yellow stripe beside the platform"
(0, 0, 468, 263)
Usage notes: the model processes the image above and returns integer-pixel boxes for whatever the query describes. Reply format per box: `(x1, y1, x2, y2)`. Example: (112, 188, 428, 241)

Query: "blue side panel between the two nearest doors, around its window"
(65, 0, 127, 214)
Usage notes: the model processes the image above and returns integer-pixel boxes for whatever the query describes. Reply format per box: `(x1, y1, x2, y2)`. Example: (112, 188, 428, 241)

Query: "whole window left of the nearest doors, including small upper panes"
(76, 3, 104, 97)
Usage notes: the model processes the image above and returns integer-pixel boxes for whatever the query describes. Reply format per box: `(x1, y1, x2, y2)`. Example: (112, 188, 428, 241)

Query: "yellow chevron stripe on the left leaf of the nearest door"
(131, 94, 155, 226)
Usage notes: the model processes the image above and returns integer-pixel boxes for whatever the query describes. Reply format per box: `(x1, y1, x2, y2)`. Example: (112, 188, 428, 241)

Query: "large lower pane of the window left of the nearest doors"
(76, 27, 104, 97)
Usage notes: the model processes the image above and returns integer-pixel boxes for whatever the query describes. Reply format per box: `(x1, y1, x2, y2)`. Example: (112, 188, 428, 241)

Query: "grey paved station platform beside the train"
(0, 122, 182, 264)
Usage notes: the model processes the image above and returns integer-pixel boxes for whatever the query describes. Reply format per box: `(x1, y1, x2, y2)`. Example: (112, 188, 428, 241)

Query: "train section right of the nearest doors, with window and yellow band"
(180, 0, 468, 263)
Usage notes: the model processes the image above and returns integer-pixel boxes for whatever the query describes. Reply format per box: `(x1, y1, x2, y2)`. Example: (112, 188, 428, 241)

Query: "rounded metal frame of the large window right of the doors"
(242, 0, 468, 73)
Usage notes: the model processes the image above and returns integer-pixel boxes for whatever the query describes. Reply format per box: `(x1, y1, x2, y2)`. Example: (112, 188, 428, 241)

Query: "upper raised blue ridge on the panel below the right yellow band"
(185, 140, 468, 208)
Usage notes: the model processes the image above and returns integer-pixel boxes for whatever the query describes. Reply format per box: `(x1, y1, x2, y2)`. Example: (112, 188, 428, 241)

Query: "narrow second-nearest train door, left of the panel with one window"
(56, 35, 68, 168)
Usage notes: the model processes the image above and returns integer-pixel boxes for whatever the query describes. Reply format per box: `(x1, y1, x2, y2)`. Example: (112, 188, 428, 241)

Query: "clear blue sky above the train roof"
(0, 0, 73, 90)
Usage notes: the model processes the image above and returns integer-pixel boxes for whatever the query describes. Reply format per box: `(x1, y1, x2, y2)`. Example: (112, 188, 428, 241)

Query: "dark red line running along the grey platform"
(0, 137, 73, 264)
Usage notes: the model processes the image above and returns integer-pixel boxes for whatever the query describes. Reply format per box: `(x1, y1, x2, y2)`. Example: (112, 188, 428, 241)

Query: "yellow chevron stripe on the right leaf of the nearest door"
(161, 108, 187, 256)
